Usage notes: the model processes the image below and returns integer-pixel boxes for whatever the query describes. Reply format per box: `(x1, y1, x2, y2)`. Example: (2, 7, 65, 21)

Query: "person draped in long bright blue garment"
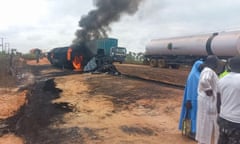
(179, 60, 203, 139)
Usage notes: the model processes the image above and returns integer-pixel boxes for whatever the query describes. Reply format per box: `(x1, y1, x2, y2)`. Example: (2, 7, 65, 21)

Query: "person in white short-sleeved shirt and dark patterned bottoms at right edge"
(218, 56, 240, 144)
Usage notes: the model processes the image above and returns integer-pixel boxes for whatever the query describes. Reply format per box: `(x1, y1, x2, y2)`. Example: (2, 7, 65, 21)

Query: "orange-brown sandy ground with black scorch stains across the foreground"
(0, 59, 196, 144)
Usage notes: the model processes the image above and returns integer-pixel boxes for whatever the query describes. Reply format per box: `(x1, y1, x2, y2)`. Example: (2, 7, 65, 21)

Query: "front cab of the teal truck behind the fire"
(110, 47, 127, 63)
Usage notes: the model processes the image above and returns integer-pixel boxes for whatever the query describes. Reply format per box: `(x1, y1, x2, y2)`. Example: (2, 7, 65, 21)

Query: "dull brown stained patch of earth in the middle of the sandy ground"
(87, 75, 178, 112)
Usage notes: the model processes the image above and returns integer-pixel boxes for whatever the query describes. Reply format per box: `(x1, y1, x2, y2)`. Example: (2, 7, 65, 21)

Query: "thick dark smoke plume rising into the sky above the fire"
(73, 0, 143, 45)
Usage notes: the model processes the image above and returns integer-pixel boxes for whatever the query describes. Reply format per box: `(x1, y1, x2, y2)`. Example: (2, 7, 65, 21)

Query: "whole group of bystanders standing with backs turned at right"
(179, 55, 240, 144)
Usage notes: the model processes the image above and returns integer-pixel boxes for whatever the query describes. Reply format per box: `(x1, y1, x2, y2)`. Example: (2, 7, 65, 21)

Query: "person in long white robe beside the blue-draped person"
(196, 55, 220, 144)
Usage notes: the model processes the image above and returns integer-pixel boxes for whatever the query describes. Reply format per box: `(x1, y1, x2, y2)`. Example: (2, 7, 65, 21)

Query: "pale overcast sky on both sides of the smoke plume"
(0, 0, 240, 53)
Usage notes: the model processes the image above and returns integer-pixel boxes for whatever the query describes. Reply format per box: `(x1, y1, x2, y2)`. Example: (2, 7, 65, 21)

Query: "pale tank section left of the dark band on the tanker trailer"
(145, 34, 211, 55)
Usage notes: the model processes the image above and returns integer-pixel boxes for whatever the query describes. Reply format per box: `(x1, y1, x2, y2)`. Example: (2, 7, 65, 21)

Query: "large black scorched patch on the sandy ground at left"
(9, 79, 77, 144)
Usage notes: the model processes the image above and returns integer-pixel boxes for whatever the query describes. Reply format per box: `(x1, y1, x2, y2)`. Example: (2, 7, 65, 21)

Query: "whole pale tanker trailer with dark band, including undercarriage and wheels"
(145, 31, 240, 68)
